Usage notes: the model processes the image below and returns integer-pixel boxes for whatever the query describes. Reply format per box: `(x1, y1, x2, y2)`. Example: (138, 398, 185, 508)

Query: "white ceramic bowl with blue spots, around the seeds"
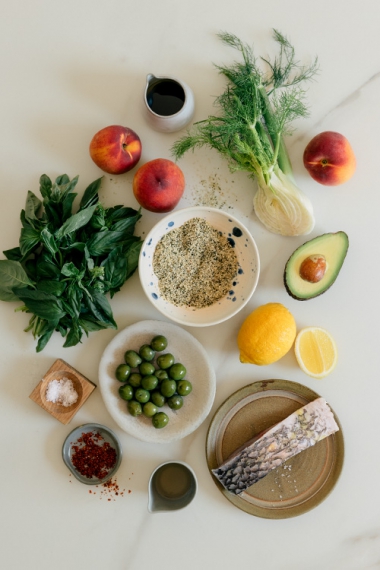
(139, 206, 260, 327)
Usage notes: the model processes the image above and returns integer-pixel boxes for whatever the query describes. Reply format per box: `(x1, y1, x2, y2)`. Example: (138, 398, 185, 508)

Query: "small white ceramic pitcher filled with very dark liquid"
(144, 73, 194, 133)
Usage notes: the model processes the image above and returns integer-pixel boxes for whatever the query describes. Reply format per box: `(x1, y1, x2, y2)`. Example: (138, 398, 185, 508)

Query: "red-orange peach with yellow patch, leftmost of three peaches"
(90, 125, 142, 174)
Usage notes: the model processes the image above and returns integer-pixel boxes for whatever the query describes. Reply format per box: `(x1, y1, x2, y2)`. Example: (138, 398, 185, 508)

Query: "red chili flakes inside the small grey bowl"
(71, 431, 117, 479)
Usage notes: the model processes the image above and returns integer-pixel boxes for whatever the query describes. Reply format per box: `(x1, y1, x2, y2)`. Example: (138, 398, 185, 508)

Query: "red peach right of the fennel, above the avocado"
(303, 131, 356, 186)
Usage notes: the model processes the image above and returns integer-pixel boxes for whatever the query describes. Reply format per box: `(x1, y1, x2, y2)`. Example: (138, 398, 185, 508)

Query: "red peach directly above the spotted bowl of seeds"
(133, 158, 185, 214)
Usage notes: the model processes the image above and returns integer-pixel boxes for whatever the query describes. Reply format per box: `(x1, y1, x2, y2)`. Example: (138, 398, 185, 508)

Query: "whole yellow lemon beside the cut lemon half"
(237, 303, 297, 366)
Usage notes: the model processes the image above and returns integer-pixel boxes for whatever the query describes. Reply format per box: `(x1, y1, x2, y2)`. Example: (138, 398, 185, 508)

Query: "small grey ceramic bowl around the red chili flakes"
(62, 423, 122, 485)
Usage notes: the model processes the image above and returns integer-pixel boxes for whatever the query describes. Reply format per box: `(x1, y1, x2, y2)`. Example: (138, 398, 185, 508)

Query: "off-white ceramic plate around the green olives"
(99, 320, 215, 443)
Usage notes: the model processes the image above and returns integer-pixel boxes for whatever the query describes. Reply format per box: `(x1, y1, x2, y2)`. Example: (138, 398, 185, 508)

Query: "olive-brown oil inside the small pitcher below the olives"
(154, 463, 192, 500)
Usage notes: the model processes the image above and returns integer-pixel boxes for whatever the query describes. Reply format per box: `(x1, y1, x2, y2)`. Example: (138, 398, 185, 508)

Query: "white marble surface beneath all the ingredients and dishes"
(0, 0, 380, 570)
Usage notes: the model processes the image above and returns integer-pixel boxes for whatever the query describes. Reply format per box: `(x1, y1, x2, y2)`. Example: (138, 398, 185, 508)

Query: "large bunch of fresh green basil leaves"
(0, 174, 142, 352)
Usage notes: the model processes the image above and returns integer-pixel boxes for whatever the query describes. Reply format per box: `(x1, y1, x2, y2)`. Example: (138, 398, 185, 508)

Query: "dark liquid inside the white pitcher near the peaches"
(146, 79, 185, 117)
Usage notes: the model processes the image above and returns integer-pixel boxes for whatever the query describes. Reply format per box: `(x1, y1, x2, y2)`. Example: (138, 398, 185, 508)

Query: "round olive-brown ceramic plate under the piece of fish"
(206, 380, 344, 519)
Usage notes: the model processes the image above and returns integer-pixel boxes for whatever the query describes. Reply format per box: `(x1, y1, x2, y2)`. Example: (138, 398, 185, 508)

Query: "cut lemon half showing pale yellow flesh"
(294, 327, 338, 378)
